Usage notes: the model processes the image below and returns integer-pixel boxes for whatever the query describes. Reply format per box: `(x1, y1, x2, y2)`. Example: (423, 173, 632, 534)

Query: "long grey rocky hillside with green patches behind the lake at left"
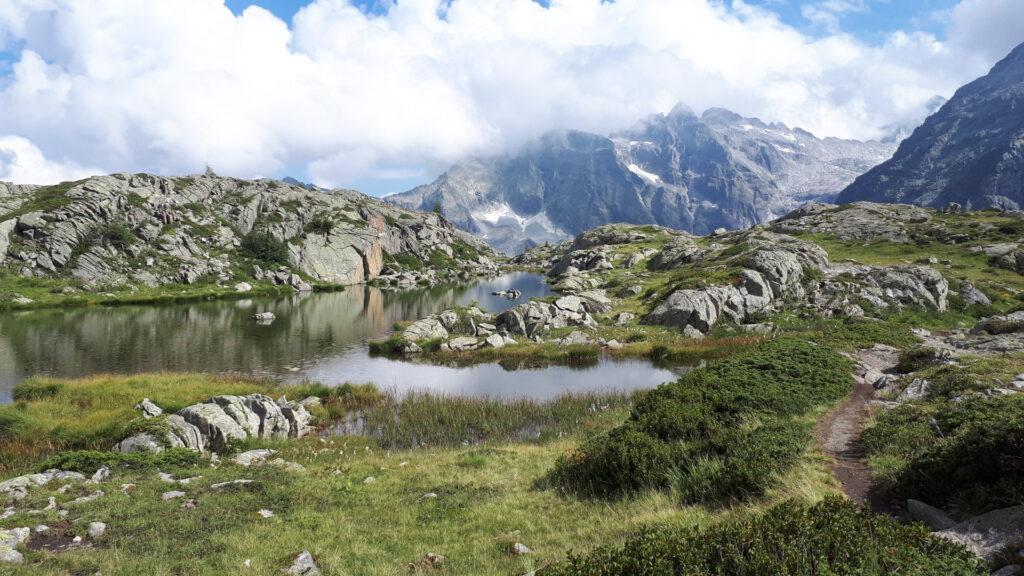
(0, 169, 494, 289)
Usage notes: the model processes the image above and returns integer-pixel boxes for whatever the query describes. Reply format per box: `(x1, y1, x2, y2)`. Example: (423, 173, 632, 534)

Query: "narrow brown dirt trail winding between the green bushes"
(814, 378, 899, 516)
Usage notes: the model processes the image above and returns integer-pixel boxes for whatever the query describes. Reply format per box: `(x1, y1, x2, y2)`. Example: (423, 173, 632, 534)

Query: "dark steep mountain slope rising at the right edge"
(839, 40, 1024, 209)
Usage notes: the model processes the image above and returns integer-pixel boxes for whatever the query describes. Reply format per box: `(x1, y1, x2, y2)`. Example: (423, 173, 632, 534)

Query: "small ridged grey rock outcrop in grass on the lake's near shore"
(114, 394, 310, 452)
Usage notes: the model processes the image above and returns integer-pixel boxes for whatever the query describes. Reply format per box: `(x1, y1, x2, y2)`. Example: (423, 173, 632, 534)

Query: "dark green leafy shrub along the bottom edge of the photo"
(541, 498, 987, 576)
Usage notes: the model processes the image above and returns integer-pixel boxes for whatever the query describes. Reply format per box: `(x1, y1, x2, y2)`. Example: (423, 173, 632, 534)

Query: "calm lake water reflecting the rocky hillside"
(0, 273, 688, 402)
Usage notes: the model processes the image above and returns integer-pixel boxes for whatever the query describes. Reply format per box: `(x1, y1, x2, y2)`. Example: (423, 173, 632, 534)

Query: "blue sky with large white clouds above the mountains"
(0, 0, 1024, 195)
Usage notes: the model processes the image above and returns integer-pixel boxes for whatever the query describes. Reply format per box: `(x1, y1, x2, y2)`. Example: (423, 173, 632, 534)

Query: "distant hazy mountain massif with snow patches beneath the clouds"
(386, 105, 895, 253)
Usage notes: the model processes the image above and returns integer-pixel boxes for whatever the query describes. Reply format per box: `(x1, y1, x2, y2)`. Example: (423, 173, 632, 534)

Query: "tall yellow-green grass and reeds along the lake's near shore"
(0, 374, 634, 476)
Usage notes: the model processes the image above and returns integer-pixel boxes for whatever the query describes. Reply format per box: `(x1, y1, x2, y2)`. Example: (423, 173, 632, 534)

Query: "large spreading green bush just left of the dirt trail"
(550, 338, 852, 502)
